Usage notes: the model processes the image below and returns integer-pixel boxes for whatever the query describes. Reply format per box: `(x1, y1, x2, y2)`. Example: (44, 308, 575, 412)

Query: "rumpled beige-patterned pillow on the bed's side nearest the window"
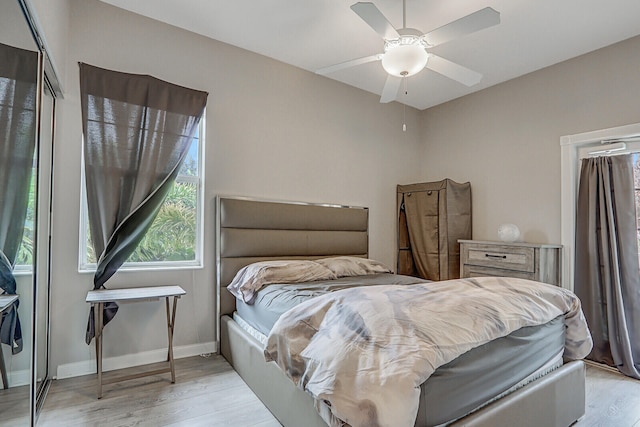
(227, 260, 337, 304)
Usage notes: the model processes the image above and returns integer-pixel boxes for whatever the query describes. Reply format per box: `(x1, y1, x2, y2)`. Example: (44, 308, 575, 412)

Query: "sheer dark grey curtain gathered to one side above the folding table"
(80, 64, 207, 344)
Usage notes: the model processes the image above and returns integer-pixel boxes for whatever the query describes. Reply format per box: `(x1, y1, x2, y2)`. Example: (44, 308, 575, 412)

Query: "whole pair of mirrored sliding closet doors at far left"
(0, 0, 59, 426)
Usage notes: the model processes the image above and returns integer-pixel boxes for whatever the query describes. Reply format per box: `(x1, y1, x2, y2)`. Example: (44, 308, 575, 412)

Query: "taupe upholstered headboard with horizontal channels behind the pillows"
(216, 196, 369, 316)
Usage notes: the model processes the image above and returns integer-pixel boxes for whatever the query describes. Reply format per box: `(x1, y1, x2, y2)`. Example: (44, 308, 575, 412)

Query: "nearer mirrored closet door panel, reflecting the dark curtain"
(0, 0, 40, 426)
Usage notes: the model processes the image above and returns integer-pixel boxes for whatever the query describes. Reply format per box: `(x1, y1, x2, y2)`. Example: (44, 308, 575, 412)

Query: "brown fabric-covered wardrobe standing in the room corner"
(396, 179, 471, 280)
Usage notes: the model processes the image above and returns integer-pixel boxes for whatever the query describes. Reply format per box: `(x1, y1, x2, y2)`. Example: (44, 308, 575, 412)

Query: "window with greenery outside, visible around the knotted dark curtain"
(79, 115, 205, 271)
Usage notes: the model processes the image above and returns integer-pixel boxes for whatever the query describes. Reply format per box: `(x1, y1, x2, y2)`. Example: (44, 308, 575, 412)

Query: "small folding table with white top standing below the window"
(86, 285, 186, 399)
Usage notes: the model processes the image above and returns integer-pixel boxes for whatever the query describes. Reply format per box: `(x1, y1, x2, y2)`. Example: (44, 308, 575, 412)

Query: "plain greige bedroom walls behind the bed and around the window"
(35, 0, 640, 373)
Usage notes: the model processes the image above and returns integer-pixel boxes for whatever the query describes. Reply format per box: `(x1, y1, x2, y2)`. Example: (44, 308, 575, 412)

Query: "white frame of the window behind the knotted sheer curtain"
(78, 117, 206, 273)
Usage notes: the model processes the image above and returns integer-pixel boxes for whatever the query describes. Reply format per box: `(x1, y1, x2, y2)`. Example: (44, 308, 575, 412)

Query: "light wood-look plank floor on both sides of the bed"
(37, 356, 640, 427)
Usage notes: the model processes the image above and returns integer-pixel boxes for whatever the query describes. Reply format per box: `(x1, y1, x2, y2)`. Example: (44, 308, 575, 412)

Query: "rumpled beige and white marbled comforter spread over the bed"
(265, 277, 592, 427)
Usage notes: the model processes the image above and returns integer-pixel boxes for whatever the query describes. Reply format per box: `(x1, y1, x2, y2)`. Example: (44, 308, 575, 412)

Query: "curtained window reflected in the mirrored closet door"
(0, 44, 39, 274)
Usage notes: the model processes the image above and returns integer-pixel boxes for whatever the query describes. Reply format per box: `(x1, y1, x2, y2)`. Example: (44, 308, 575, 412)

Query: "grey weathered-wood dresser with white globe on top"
(458, 240, 562, 286)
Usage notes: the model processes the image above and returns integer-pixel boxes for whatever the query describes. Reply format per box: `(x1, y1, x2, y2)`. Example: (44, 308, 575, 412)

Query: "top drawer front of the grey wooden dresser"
(462, 245, 535, 273)
